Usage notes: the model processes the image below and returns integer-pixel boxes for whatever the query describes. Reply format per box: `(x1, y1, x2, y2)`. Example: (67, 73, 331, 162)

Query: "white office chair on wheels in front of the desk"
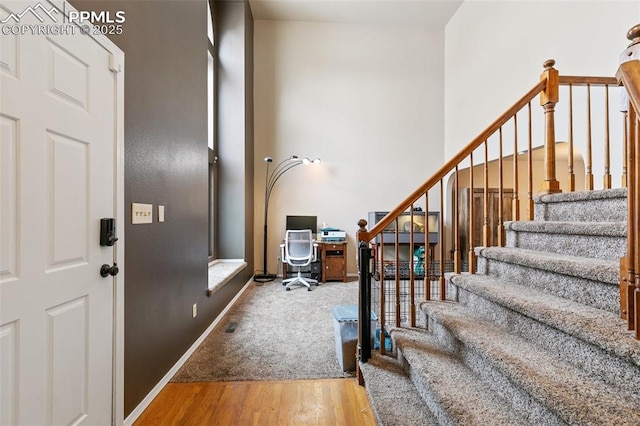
(280, 229, 318, 291)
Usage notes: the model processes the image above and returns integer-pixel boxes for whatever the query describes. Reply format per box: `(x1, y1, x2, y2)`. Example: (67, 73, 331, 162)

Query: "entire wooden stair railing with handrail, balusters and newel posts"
(357, 25, 640, 376)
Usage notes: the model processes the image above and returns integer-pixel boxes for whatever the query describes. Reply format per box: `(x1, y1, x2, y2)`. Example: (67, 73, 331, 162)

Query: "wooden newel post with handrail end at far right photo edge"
(616, 24, 640, 339)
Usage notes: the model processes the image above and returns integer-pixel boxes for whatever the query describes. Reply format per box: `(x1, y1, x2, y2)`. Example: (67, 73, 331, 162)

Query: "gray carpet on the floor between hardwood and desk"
(171, 280, 358, 382)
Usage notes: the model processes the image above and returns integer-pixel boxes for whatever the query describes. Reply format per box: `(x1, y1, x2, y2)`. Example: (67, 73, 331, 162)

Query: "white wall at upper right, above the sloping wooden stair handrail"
(444, 1, 640, 188)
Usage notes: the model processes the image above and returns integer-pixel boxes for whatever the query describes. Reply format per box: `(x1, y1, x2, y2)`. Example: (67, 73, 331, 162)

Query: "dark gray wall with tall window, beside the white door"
(71, 0, 253, 416)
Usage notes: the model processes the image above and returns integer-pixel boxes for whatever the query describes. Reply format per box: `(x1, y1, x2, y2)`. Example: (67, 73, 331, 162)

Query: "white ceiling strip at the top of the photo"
(249, 0, 463, 27)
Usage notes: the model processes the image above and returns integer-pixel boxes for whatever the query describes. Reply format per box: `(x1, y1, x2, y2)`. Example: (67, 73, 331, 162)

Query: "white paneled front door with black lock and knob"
(0, 0, 123, 425)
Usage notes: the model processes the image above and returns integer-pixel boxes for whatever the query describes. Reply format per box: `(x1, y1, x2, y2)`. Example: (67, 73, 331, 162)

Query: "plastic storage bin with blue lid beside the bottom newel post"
(333, 305, 378, 371)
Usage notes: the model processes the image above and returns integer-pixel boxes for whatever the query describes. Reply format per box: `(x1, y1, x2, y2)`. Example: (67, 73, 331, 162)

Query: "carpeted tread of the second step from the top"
(504, 220, 627, 238)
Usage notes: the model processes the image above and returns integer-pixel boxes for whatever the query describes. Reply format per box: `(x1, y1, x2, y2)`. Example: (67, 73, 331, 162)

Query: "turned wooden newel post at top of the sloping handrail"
(540, 59, 562, 194)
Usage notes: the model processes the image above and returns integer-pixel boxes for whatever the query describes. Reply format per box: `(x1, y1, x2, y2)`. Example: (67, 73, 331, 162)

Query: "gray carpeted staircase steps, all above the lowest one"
(360, 188, 640, 426)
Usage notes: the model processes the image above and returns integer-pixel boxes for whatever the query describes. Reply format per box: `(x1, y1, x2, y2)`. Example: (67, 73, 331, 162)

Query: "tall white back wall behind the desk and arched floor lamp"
(254, 20, 444, 273)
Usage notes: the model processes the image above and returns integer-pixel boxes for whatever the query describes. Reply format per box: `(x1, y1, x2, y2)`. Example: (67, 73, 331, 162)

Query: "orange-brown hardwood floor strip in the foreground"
(134, 379, 377, 426)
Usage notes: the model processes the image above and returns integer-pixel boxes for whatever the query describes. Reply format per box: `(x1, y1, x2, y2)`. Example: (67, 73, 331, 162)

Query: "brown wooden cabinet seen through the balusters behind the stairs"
(458, 188, 513, 259)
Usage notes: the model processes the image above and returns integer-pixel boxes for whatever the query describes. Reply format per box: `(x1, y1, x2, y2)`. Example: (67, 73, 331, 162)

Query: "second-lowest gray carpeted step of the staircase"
(391, 328, 526, 425)
